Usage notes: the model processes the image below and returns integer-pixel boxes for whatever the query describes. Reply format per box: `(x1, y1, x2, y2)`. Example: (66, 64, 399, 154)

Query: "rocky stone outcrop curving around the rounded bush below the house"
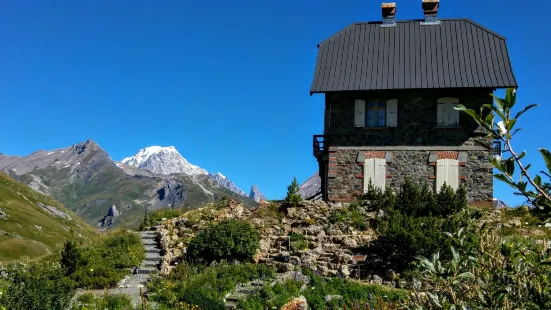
(155, 201, 376, 277)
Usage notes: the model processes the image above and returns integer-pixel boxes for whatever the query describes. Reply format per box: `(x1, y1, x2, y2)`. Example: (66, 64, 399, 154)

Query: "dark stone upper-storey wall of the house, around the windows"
(325, 89, 492, 146)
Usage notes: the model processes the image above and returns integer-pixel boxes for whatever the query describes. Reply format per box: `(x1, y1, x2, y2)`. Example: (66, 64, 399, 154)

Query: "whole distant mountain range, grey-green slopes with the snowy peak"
(0, 140, 256, 229)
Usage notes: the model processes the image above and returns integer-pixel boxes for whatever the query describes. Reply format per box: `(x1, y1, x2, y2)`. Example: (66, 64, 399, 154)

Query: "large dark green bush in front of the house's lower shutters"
(369, 180, 479, 271)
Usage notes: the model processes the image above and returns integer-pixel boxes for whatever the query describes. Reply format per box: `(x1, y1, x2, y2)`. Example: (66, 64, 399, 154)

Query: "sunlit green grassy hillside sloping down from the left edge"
(0, 172, 95, 263)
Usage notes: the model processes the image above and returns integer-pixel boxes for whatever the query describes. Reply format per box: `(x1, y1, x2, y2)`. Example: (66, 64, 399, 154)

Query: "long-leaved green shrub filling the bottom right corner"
(407, 226, 551, 309)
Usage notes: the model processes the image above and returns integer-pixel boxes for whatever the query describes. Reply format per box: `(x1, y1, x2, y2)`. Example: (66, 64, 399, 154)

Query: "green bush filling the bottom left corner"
(0, 262, 75, 310)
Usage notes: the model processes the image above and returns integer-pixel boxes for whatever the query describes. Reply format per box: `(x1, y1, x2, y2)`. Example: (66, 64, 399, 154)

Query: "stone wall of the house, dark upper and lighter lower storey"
(325, 89, 493, 202)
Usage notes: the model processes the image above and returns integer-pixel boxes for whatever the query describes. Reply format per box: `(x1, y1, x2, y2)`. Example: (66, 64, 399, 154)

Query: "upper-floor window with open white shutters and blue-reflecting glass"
(354, 99, 398, 127)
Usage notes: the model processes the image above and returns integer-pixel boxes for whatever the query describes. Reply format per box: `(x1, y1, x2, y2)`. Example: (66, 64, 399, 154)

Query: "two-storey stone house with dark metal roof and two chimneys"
(310, 0, 517, 203)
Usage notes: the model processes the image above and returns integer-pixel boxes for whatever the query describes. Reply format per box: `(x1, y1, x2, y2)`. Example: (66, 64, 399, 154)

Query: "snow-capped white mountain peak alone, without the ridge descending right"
(121, 145, 208, 175)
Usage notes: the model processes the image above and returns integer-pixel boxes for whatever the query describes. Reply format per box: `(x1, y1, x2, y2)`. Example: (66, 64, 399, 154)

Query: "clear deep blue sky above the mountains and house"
(0, 0, 551, 205)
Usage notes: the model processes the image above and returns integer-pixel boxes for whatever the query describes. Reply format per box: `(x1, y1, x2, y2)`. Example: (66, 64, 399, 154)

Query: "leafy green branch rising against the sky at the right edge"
(456, 88, 551, 212)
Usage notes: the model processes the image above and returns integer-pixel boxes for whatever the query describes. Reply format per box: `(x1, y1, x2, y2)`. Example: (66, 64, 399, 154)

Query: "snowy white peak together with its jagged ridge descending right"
(121, 146, 264, 202)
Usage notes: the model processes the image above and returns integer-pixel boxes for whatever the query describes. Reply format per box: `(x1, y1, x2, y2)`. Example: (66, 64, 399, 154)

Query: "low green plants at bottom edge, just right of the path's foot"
(148, 263, 275, 310)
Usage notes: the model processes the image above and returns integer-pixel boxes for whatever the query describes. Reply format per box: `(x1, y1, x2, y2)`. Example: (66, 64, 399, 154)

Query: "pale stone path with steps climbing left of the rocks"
(73, 231, 162, 306)
